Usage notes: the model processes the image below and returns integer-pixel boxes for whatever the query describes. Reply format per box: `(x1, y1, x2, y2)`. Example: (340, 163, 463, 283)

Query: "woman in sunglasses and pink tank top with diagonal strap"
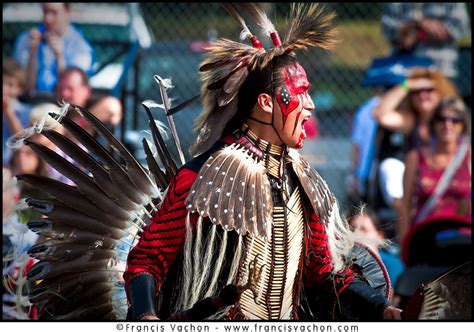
(399, 97, 472, 242)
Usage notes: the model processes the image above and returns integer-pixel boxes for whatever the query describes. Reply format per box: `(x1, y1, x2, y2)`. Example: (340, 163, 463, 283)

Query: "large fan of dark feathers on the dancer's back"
(11, 90, 181, 320)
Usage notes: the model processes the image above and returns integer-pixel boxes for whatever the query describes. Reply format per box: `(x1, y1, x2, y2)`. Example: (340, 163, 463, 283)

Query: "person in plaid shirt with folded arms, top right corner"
(382, 2, 471, 80)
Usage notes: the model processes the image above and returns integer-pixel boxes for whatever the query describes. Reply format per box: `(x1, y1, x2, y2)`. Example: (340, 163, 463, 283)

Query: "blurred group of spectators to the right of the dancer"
(348, 3, 472, 308)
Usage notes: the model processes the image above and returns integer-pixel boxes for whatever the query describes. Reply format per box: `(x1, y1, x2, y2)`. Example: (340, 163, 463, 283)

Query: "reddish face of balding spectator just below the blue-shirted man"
(57, 72, 91, 107)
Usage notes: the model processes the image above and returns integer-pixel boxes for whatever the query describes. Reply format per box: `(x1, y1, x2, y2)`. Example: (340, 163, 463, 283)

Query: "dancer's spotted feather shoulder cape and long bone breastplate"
(186, 126, 350, 320)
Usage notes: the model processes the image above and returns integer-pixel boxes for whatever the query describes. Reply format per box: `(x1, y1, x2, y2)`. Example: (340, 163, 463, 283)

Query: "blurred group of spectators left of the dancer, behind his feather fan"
(2, 3, 123, 319)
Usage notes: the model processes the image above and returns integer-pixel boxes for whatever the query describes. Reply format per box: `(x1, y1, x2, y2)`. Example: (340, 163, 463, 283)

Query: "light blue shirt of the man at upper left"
(13, 24, 94, 92)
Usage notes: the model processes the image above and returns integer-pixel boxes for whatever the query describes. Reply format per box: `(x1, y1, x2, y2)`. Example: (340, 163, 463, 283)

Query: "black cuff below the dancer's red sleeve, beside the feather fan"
(128, 273, 157, 320)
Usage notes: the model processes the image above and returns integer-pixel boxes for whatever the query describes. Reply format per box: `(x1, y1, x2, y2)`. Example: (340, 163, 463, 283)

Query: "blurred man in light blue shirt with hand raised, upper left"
(14, 3, 94, 93)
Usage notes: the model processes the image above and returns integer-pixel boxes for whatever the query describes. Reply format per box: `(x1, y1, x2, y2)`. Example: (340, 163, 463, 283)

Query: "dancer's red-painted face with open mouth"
(272, 63, 314, 149)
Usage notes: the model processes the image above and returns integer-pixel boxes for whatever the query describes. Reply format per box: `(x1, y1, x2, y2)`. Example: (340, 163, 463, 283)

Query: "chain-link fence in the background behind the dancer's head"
(3, 2, 471, 210)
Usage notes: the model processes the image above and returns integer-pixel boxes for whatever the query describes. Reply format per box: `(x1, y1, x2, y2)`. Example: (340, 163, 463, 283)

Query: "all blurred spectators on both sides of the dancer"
(3, 3, 472, 319)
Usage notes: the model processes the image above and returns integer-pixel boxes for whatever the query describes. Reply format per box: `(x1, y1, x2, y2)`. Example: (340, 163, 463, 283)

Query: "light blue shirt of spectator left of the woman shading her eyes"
(351, 96, 380, 190)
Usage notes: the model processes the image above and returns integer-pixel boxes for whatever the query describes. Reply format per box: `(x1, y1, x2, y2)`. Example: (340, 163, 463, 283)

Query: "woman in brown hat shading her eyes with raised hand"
(373, 68, 457, 222)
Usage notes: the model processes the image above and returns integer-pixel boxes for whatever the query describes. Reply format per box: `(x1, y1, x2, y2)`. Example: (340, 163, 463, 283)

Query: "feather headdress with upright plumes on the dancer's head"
(190, 3, 337, 155)
